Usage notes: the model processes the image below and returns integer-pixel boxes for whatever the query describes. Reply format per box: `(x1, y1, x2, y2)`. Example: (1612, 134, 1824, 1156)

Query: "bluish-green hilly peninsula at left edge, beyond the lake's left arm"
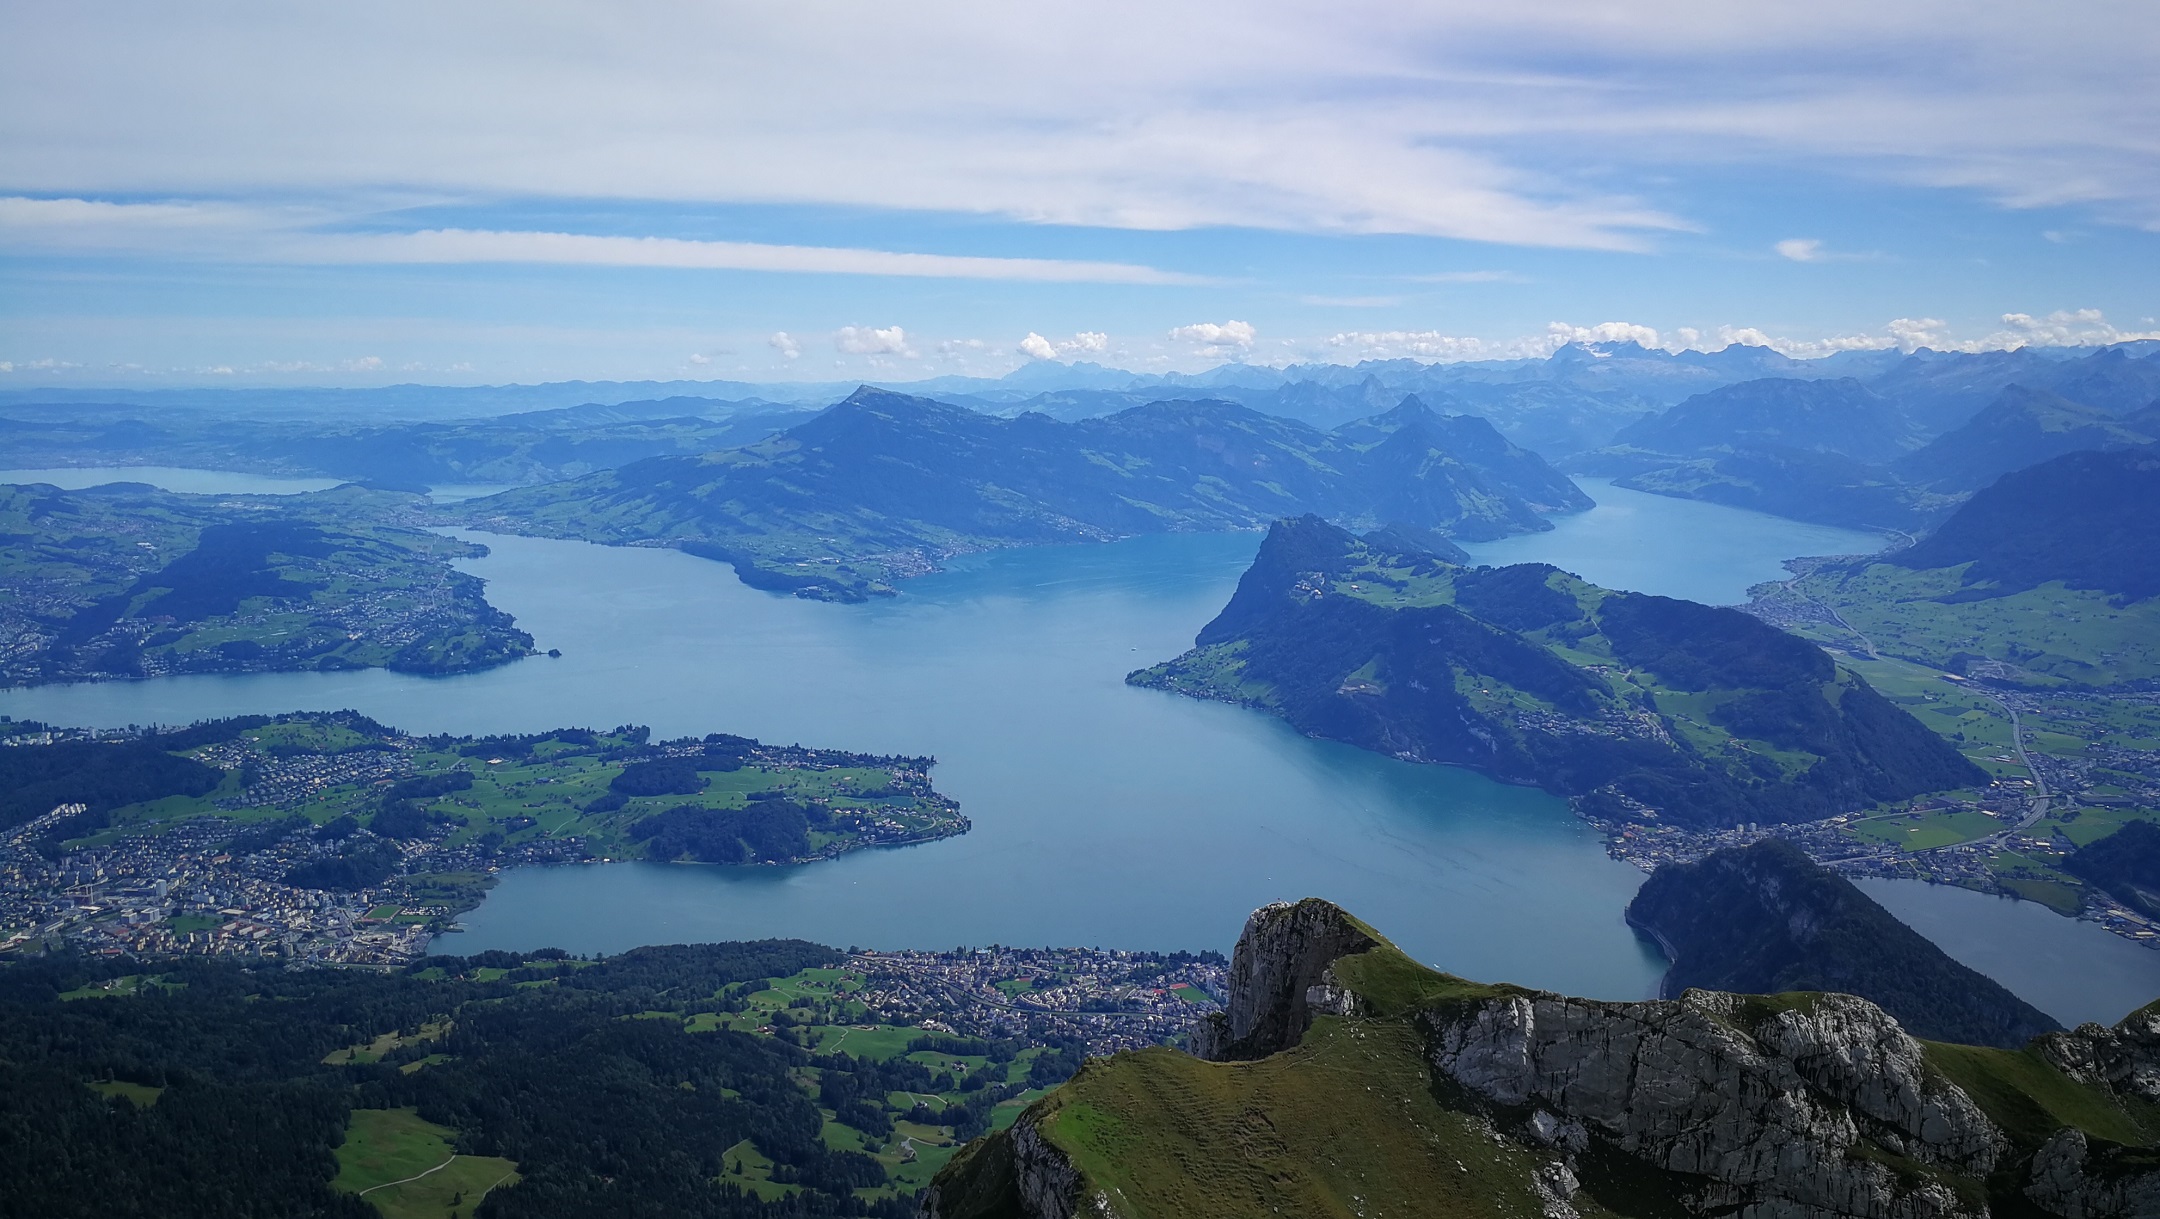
(0, 482, 534, 685)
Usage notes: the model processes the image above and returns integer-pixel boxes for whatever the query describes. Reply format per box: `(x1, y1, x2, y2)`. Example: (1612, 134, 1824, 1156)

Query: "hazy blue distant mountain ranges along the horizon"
(0, 341, 2160, 501)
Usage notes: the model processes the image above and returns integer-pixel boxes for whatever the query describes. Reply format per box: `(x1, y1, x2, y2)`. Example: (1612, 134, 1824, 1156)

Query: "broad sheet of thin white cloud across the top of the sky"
(12, 0, 2160, 249)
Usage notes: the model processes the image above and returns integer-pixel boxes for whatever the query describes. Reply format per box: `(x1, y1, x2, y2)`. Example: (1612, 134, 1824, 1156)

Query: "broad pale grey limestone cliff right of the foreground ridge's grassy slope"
(1426, 992, 2002, 1219)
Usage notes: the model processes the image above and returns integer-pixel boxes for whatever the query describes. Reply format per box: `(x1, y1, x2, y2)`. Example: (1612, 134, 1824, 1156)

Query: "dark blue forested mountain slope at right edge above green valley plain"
(1888, 445, 2160, 601)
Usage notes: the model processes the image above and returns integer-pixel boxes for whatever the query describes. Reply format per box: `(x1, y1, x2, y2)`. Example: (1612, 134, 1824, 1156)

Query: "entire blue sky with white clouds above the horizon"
(0, 0, 2160, 387)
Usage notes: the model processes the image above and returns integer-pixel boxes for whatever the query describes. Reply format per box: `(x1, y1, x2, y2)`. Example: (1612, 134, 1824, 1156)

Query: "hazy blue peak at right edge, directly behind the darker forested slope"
(1896, 385, 2156, 493)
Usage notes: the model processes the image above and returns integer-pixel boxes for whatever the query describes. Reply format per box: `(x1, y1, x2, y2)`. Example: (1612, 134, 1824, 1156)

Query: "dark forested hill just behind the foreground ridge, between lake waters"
(1626, 839, 2061, 1048)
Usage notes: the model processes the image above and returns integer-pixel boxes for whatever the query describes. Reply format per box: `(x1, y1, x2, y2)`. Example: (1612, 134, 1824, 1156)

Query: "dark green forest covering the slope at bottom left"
(0, 940, 997, 1219)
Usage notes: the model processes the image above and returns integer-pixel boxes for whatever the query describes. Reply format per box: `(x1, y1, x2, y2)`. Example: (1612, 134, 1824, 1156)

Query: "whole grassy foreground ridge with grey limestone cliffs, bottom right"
(922, 899, 2160, 1219)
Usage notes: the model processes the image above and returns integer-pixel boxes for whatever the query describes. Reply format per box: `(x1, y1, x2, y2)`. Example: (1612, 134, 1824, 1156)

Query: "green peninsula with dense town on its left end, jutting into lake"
(0, 711, 968, 964)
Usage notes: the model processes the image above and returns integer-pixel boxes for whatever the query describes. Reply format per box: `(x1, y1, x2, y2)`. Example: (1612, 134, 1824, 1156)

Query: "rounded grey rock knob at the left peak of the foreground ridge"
(1192, 897, 1380, 1061)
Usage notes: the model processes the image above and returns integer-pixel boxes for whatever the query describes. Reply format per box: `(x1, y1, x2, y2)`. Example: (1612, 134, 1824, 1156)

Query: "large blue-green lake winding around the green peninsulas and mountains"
(0, 471, 2160, 1020)
